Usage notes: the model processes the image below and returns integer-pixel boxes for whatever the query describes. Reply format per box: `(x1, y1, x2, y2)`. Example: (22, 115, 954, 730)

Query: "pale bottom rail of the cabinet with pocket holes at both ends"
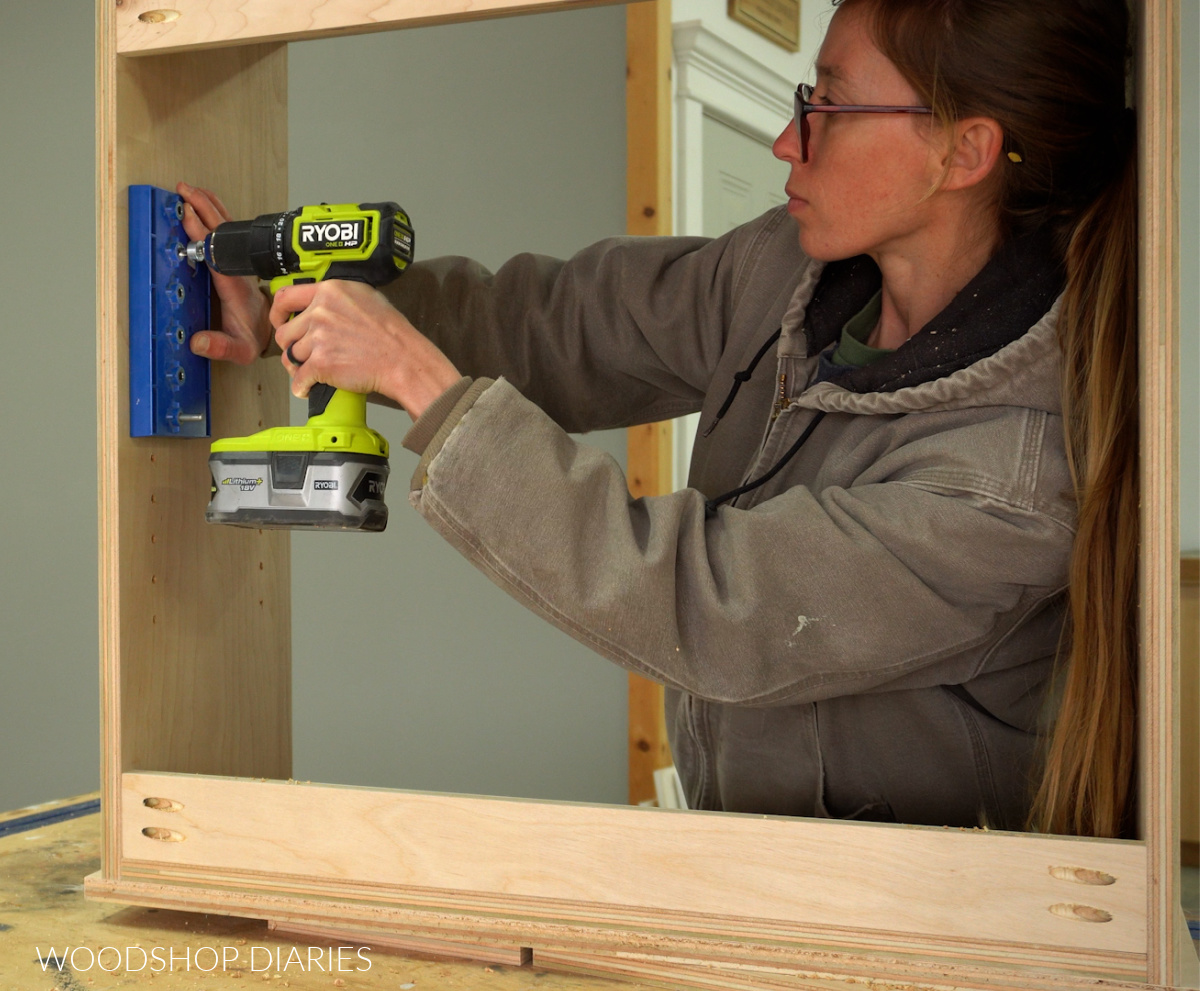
(101, 774, 1146, 967)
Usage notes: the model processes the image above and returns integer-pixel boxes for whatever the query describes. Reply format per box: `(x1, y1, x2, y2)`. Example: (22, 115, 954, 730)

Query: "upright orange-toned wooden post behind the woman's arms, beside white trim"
(625, 0, 673, 805)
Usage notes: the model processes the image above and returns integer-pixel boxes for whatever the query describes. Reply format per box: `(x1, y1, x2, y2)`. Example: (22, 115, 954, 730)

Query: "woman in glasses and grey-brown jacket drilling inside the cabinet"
(180, 0, 1136, 835)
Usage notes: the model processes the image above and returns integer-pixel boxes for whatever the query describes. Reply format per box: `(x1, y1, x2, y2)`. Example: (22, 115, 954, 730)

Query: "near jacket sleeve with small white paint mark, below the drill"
(410, 379, 1070, 705)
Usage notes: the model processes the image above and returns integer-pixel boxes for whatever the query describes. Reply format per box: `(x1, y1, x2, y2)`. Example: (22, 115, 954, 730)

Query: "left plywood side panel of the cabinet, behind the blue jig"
(100, 46, 292, 796)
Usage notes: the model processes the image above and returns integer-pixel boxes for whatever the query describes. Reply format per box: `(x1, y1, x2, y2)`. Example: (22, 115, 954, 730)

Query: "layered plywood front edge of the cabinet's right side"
(1138, 0, 1192, 984)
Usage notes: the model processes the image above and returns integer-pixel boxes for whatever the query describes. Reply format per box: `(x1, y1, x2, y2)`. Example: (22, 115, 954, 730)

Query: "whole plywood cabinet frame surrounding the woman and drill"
(86, 0, 1192, 987)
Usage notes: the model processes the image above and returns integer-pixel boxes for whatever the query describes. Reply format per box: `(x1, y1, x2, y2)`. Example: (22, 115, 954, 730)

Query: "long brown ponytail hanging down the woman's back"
(1031, 110, 1139, 836)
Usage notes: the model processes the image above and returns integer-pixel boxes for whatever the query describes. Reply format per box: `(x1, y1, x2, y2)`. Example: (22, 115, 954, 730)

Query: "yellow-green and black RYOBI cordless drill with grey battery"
(186, 203, 414, 530)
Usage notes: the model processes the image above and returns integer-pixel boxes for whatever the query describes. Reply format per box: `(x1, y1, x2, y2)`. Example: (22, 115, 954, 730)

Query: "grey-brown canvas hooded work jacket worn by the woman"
(388, 210, 1074, 828)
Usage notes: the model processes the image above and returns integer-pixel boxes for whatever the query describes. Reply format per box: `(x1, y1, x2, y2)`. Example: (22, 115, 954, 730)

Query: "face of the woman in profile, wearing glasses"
(773, 7, 942, 262)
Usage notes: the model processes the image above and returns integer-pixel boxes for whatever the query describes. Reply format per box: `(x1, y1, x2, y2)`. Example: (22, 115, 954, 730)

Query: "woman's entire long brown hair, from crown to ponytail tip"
(834, 0, 1139, 836)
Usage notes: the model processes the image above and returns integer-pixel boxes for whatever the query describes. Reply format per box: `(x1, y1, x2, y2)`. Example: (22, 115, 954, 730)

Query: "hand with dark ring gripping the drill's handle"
(270, 280, 461, 420)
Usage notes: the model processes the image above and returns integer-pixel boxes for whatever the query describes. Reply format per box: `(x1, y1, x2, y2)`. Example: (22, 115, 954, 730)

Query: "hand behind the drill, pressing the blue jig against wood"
(175, 182, 271, 365)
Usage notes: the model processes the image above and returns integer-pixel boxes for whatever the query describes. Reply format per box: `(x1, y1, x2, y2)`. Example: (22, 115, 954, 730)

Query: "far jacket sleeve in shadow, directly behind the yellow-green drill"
(384, 212, 762, 432)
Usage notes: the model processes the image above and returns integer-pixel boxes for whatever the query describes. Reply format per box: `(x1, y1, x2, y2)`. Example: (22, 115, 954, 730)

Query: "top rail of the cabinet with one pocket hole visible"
(117, 0, 613, 55)
